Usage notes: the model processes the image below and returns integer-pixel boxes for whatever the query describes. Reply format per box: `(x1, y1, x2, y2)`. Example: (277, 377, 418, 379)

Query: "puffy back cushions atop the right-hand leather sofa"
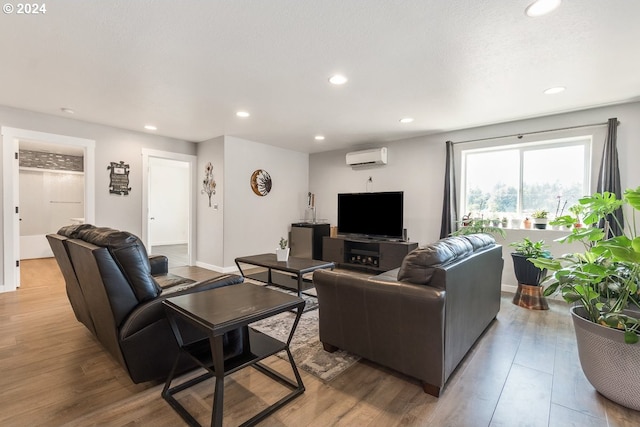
(398, 234, 495, 285)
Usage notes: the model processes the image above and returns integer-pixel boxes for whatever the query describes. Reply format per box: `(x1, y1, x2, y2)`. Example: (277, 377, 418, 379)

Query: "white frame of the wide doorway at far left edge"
(0, 126, 96, 292)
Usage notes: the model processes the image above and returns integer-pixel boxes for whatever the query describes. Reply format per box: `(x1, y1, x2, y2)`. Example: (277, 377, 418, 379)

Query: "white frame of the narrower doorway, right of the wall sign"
(141, 148, 198, 265)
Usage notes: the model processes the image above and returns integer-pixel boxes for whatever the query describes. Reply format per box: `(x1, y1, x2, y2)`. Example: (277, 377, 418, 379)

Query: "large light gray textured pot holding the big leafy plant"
(571, 306, 640, 411)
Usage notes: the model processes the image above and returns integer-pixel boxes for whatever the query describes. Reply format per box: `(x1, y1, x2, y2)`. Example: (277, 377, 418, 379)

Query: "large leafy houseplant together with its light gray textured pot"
(533, 187, 640, 410)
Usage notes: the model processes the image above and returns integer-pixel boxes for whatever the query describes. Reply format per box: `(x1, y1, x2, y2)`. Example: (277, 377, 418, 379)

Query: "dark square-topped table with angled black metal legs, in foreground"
(162, 283, 305, 426)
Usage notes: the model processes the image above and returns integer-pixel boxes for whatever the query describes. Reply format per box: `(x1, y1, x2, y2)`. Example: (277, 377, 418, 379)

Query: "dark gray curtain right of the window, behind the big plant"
(596, 118, 624, 236)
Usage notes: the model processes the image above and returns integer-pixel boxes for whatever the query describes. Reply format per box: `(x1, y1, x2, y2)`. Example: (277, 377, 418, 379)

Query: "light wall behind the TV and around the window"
(309, 102, 640, 284)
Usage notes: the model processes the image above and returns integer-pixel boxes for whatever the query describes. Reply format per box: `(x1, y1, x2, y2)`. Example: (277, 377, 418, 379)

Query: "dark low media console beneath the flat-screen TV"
(322, 236, 418, 271)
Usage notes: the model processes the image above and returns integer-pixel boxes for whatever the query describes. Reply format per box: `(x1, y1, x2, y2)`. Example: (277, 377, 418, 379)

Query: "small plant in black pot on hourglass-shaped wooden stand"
(509, 237, 551, 310)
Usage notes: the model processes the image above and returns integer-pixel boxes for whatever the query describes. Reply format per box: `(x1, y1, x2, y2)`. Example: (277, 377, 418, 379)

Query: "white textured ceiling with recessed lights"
(0, 0, 640, 152)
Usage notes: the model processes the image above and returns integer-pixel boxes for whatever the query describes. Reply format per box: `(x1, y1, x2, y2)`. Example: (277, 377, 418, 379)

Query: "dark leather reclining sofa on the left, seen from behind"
(47, 224, 246, 383)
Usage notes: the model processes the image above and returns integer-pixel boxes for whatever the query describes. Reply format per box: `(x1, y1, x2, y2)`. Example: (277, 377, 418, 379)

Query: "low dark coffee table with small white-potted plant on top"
(236, 254, 335, 296)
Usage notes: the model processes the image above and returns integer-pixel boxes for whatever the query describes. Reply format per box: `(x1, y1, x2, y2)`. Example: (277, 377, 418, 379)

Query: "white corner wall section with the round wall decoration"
(198, 136, 309, 271)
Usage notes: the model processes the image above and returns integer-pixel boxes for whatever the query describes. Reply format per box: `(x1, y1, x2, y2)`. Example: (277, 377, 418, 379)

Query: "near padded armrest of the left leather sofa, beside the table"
(120, 274, 244, 340)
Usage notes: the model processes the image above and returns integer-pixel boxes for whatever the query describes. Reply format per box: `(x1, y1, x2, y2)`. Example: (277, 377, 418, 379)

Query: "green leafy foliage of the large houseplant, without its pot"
(532, 187, 640, 343)
